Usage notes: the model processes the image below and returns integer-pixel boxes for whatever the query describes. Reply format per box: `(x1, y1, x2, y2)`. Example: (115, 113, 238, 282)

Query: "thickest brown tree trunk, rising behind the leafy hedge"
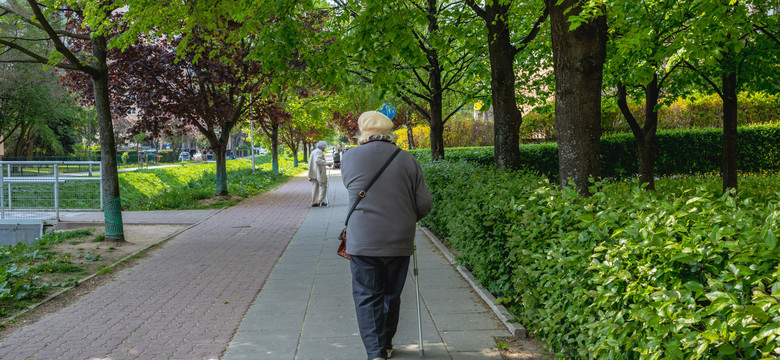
(546, 0, 607, 195)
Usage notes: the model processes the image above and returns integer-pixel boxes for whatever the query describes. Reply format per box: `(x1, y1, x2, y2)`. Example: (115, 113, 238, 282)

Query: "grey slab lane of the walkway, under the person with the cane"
(224, 171, 510, 360)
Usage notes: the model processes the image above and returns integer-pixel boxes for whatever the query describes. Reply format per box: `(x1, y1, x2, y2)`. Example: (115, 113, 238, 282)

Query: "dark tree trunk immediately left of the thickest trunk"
(485, 2, 523, 170)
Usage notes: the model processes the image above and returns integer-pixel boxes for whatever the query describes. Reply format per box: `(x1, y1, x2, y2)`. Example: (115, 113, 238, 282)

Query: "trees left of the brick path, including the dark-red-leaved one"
(0, 1, 336, 241)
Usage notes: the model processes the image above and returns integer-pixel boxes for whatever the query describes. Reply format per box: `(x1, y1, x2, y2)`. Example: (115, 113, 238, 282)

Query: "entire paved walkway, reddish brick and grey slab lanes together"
(0, 171, 509, 360)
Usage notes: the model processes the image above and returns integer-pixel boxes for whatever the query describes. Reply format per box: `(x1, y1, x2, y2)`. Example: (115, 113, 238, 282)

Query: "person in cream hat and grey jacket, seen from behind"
(341, 111, 433, 360)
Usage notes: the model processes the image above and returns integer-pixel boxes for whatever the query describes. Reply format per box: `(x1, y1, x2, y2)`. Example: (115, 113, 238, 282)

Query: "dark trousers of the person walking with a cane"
(350, 255, 409, 360)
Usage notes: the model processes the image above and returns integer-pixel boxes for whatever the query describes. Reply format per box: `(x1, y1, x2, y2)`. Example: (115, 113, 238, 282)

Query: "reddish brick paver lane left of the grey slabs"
(0, 176, 311, 360)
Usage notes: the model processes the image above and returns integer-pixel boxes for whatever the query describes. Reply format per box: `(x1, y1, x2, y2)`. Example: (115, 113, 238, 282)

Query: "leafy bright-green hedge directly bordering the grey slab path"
(421, 161, 780, 359)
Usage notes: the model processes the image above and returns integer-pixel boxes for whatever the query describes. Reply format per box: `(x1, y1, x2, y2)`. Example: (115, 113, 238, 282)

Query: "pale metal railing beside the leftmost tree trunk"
(0, 161, 103, 220)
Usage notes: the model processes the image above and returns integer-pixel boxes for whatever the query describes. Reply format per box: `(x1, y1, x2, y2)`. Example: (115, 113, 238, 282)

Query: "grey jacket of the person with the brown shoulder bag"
(341, 141, 433, 256)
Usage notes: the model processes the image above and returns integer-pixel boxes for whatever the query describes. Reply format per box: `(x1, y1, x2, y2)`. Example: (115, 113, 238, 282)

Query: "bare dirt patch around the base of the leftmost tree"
(0, 225, 188, 338)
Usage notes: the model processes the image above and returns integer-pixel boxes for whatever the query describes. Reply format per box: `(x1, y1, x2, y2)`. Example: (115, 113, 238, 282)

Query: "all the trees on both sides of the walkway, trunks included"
(0, 0, 780, 242)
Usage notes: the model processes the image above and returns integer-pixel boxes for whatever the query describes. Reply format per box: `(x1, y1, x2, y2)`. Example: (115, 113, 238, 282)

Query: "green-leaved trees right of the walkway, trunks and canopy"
(328, 0, 780, 193)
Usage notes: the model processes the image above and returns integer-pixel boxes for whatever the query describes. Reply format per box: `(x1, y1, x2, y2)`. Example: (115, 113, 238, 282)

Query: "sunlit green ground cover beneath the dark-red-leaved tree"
(119, 156, 299, 210)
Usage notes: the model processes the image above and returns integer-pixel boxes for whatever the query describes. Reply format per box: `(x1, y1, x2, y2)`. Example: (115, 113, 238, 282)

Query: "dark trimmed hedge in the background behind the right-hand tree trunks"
(412, 124, 780, 180)
